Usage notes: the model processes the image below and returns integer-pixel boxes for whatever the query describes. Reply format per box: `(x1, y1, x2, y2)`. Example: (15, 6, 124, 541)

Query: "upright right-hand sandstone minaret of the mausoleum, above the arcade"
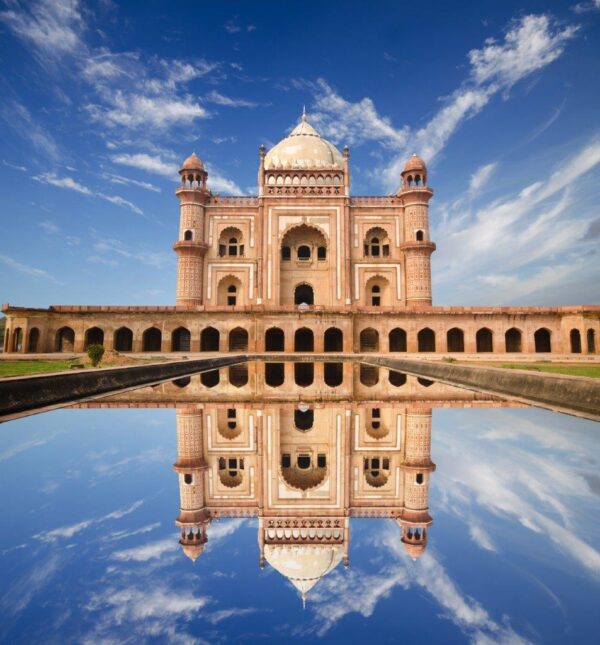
(397, 154, 435, 307)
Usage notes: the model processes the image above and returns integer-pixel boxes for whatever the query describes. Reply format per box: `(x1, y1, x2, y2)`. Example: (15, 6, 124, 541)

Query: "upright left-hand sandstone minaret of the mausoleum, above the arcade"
(173, 153, 210, 307)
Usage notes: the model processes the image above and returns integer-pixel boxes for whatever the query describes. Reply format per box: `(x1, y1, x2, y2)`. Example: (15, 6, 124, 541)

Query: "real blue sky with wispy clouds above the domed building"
(0, 0, 600, 306)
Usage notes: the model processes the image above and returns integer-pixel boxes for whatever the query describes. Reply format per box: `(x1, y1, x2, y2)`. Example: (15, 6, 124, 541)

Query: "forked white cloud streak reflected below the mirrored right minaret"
(310, 523, 529, 645)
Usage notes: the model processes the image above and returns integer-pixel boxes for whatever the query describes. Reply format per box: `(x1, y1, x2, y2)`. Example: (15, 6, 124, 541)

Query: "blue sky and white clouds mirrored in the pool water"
(0, 409, 600, 645)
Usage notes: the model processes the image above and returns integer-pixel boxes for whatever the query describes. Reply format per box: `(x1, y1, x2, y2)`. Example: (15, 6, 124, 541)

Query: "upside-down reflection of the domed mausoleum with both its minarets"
(174, 403, 435, 598)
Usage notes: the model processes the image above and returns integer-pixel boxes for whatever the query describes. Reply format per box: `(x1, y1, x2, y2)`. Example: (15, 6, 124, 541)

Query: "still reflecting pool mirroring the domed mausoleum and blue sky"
(0, 386, 600, 644)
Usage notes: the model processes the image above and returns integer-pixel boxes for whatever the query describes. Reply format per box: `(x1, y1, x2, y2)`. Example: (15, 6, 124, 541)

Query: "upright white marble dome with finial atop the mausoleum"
(265, 114, 344, 170)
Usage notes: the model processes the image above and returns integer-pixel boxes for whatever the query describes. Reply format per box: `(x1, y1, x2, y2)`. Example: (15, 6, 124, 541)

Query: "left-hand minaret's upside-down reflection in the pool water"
(173, 405, 211, 561)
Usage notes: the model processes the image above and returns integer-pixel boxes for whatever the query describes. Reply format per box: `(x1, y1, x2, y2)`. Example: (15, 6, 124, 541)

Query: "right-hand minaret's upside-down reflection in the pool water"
(397, 407, 435, 560)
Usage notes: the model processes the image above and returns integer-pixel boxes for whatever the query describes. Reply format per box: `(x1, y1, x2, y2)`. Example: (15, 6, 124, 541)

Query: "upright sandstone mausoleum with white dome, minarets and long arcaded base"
(3, 110, 600, 362)
